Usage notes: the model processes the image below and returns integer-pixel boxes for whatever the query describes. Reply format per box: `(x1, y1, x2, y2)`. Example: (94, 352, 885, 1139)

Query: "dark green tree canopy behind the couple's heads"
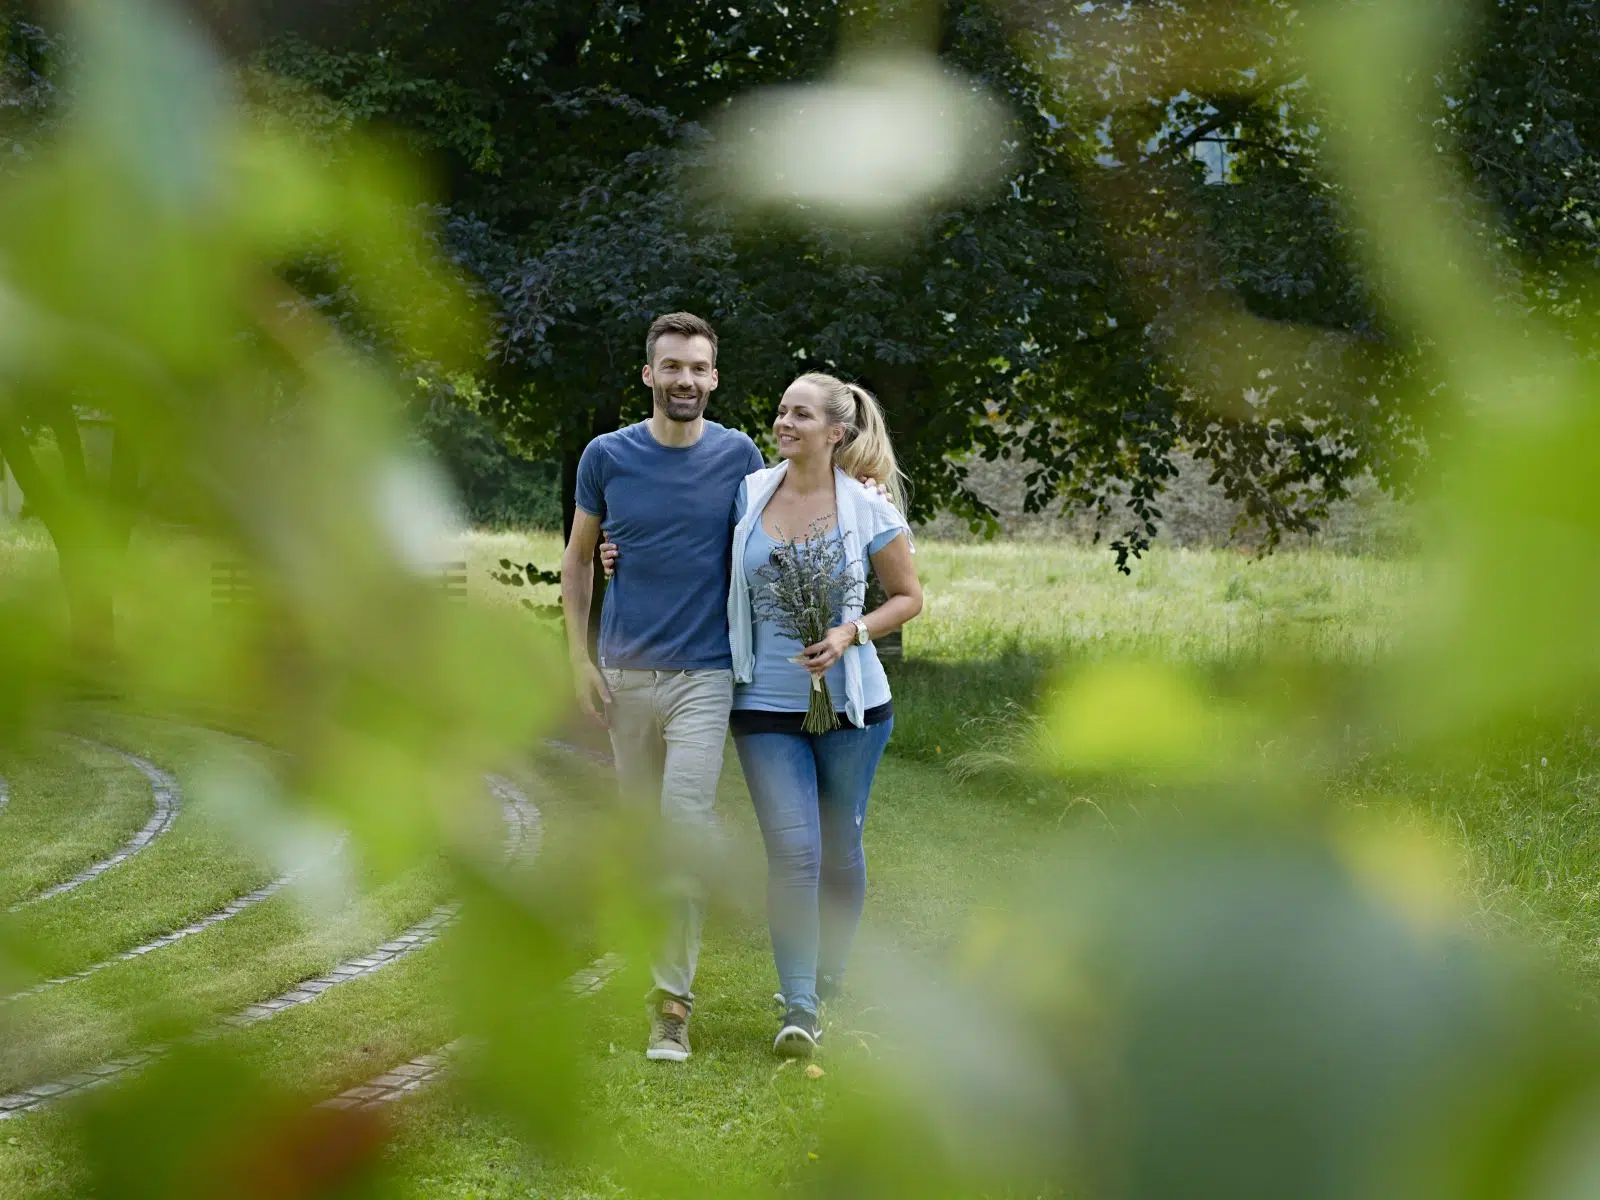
(8, 0, 1600, 555)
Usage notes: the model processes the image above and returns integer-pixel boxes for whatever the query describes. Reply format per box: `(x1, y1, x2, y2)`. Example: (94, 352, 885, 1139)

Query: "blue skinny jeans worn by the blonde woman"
(733, 718, 894, 1013)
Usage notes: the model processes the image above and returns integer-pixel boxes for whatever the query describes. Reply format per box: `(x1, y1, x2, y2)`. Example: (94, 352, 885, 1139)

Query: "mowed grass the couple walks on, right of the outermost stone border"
(368, 755, 1056, 1200)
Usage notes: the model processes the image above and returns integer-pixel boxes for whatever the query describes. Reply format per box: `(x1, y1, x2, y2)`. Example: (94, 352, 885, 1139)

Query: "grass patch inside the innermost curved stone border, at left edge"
(0, 736, 155, 912)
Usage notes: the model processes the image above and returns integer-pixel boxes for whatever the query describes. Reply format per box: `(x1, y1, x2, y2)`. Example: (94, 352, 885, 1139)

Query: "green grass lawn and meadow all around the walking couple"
(0, 534, 1600, 1200)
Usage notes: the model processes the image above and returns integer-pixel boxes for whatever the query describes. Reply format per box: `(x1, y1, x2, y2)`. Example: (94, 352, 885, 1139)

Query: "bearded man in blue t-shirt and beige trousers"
(562, 312, 763, 1062)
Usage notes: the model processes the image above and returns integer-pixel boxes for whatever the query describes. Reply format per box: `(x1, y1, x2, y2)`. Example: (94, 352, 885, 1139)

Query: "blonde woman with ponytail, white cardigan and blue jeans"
(728, 374, 922, 1056)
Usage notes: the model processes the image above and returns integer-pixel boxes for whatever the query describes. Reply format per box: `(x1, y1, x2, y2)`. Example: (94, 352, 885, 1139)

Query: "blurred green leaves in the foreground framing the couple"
(0, 0, 1600, 1200)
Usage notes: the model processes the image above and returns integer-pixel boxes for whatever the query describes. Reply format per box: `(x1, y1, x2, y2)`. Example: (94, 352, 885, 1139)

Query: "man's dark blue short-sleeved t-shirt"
(576, 421, 765, 670)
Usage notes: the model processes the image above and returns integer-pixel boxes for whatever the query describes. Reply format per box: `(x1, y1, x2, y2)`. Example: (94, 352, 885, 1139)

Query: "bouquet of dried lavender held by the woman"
(754, 518, 861, 733)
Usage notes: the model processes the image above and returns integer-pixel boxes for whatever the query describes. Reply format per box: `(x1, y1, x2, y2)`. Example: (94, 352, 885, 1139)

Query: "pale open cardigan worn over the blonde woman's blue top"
(728, 462, 909, 728)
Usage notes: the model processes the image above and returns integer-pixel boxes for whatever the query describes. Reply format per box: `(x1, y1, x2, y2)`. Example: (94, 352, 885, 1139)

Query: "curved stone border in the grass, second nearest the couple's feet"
(0, 776, 542, 1120)
